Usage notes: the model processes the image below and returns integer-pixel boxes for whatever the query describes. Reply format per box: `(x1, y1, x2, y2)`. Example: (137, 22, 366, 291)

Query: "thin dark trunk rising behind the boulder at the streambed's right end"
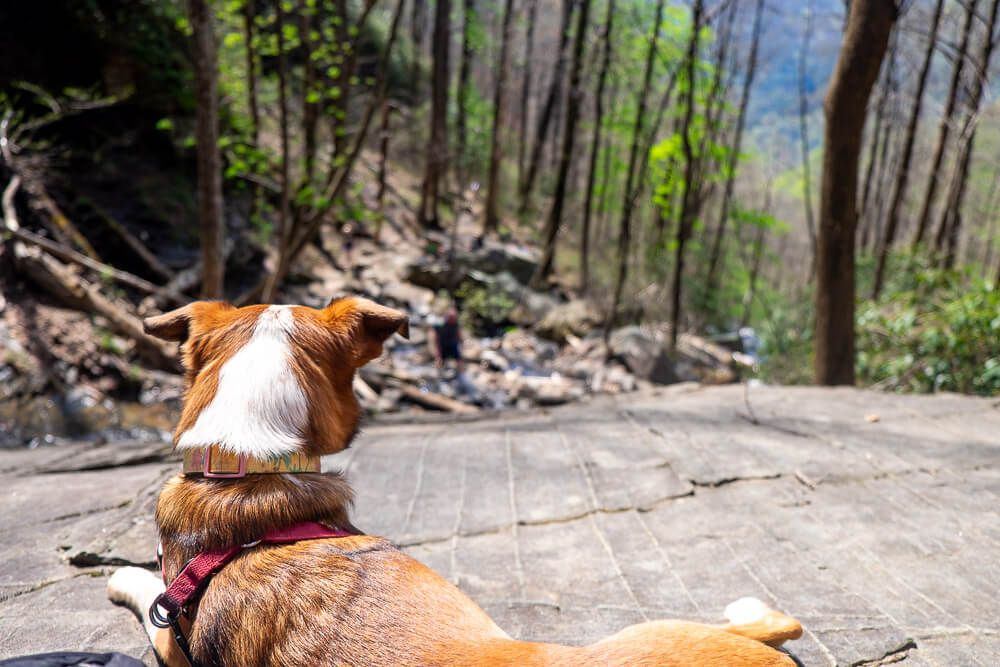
(670, 0, 704, 349)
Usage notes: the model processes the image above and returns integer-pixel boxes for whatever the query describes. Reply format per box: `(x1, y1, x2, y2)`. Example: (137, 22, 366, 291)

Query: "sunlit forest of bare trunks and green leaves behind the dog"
(0, 0, 1000, 444)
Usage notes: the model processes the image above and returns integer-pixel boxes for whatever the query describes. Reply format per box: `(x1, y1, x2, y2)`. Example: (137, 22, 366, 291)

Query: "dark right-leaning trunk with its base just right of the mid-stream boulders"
(533, 0, 590, 285)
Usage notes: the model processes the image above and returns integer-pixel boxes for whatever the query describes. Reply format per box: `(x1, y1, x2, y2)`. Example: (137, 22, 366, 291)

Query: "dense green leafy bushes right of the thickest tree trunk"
(857, 258, 1000, 396)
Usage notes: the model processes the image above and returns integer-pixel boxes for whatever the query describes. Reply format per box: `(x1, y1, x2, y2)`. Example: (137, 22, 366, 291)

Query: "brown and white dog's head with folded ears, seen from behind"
(143, 297, 409, 459)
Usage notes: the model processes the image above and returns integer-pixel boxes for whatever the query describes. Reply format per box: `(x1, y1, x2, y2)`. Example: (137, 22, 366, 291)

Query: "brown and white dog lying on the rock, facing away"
(108, 298, 802, 667)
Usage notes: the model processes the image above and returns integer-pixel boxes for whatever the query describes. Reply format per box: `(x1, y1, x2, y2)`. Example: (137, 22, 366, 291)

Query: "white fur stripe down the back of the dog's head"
(177, 306, 309, 459)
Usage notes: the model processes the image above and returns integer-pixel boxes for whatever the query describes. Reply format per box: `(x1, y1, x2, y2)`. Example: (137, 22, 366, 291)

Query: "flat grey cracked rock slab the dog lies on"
(0, 386, 1000, 666)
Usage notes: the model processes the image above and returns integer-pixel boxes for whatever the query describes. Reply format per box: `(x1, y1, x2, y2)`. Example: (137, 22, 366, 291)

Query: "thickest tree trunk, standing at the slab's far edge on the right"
(815, 0, 898, 385)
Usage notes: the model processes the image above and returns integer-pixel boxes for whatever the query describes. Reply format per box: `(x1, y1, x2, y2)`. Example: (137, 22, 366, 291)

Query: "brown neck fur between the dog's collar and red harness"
(156, 473, 356, 580)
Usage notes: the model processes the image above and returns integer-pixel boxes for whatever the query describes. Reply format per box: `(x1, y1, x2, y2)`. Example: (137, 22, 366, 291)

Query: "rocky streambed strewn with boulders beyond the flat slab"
(0, 232, 752, 447)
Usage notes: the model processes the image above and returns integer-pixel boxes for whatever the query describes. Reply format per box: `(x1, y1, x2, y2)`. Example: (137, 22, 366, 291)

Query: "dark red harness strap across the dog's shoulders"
(149, 521, 357, 665)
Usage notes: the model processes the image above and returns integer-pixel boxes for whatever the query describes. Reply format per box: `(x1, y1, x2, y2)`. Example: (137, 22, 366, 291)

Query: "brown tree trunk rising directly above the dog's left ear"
(189, 0, 226, 299)
